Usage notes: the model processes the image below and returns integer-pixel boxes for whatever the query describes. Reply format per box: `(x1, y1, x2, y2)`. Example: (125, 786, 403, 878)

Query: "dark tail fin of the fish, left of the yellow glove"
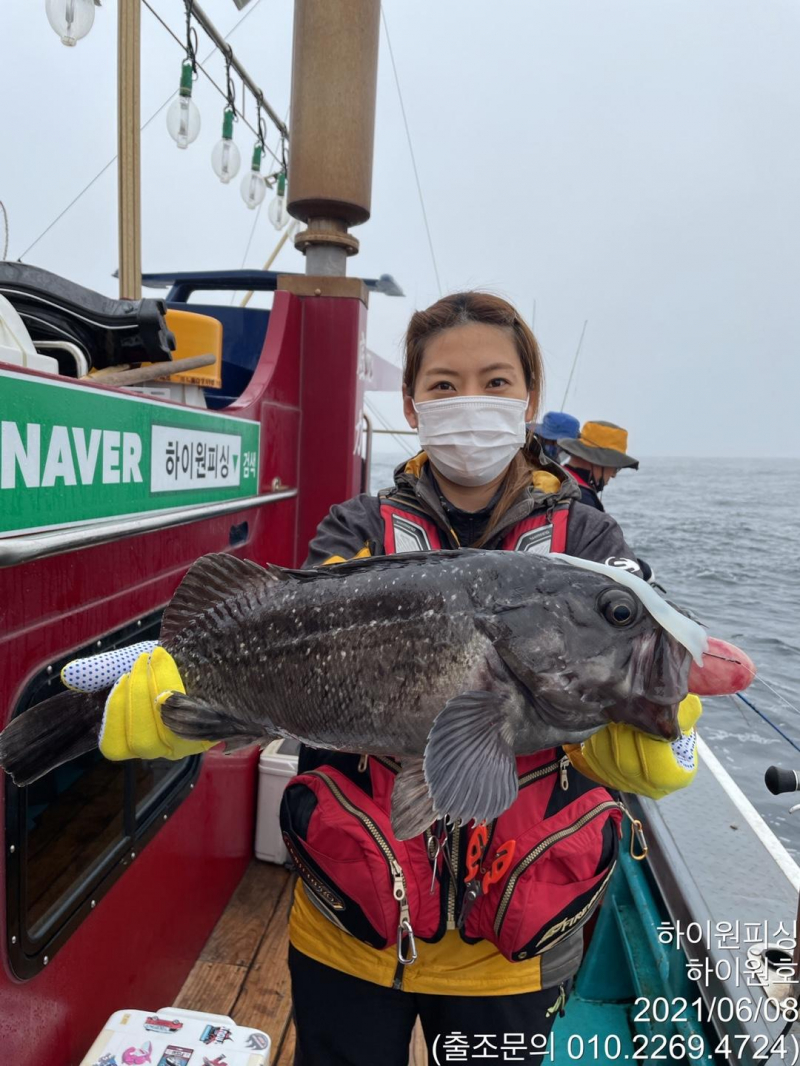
(0, 692, 108, 786)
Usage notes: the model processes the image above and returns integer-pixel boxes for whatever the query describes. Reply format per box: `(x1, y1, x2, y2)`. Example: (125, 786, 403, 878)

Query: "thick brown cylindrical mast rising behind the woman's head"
(288, 0, 381, 277)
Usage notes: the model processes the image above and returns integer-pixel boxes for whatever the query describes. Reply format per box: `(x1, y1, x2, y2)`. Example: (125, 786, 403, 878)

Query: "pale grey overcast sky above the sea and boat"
(0, 0, 800, 456)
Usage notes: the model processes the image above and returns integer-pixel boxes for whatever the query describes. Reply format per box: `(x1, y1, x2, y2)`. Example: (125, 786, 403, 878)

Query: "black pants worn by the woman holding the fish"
(289, 947, 572, 1066)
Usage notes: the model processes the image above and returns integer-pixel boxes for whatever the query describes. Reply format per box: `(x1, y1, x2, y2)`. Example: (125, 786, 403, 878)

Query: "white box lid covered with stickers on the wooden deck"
(80, 1006, 270, 1066)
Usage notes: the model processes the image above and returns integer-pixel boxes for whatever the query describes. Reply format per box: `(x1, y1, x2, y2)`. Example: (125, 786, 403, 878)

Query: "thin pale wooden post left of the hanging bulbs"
(116, 0, 142, 300)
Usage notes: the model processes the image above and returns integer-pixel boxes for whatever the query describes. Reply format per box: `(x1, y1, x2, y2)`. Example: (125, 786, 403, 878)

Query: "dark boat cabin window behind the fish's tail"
(5, 612, 199, 978)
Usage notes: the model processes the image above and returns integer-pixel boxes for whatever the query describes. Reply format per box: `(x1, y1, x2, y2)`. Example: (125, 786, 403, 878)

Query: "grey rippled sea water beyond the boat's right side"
(371, 449, 800, 861)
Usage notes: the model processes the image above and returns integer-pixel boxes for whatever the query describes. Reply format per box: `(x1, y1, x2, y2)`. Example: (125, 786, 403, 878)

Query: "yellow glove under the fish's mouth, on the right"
(564, 695, 703, 800)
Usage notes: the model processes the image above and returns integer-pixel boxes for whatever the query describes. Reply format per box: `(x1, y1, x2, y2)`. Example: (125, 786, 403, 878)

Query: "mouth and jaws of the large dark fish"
(608, 630, 692, 741)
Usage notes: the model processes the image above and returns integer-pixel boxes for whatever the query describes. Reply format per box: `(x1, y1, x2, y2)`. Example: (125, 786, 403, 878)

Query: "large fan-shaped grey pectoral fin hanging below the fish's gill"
(425, 692, 518, 823)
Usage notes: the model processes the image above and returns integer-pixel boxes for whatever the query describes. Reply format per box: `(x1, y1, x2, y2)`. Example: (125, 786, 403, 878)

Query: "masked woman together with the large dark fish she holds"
(0, 292, 749, 1066)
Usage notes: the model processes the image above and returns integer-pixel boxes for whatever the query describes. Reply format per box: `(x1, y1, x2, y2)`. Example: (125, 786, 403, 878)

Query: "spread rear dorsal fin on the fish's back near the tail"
(160, 553, 290, 646)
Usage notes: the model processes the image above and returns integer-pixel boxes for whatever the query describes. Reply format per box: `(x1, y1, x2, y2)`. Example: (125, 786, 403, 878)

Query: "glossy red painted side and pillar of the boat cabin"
(0, 293, 366, 1066)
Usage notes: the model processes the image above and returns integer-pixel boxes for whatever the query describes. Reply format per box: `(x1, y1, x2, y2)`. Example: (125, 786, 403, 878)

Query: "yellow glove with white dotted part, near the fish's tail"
(61, 641, 217, 762)
